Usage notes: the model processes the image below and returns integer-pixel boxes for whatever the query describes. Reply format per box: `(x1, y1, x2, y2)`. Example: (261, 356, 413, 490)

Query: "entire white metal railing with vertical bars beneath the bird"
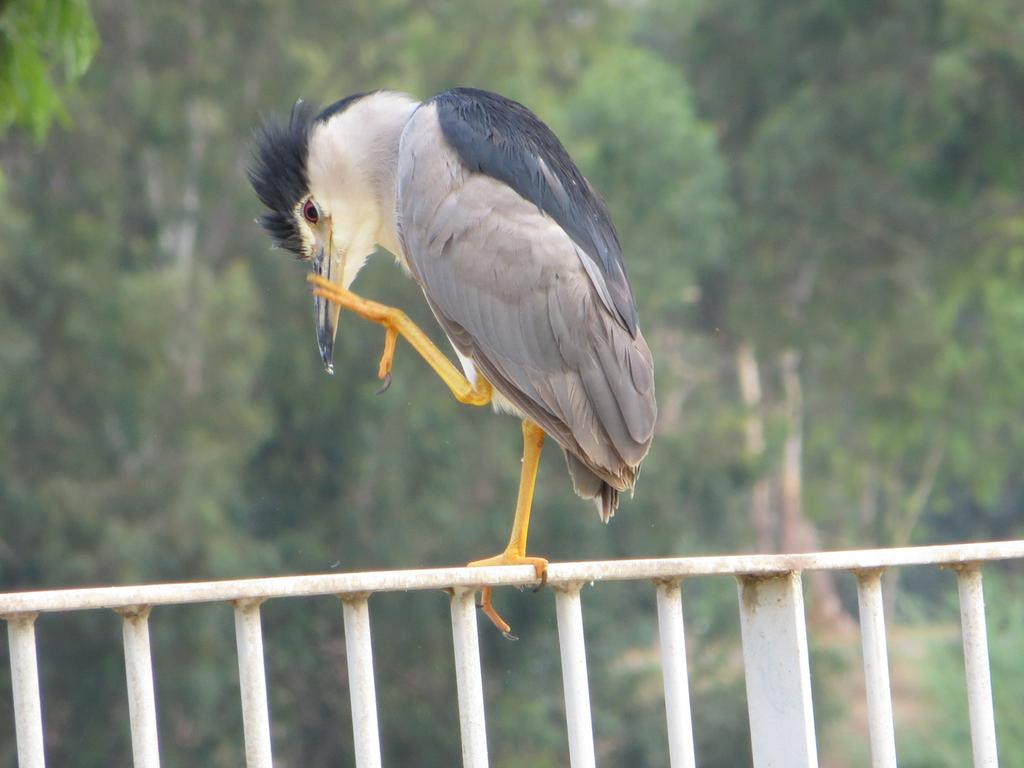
(0, 541, 1024, 768)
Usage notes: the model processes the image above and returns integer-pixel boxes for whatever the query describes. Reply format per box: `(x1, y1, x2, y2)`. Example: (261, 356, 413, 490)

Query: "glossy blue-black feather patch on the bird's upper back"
(431, 88, 637, 338)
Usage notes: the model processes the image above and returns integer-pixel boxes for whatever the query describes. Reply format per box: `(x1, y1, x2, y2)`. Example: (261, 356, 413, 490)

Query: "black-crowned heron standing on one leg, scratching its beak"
(248, 88, 657, 636)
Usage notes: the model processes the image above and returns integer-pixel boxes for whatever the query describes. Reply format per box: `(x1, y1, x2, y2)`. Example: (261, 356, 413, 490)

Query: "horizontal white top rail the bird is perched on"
(0, 540, 1024, 616)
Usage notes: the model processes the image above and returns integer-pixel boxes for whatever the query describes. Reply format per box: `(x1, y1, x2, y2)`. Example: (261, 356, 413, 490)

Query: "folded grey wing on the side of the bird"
(396, 102, 656, 489)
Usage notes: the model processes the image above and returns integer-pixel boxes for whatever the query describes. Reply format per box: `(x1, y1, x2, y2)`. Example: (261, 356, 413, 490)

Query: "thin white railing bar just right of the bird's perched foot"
(555, 584, 596, 768)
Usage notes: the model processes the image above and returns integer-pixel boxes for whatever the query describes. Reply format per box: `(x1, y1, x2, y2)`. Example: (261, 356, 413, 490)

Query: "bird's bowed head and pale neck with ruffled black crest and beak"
(249, 91, 416, 373)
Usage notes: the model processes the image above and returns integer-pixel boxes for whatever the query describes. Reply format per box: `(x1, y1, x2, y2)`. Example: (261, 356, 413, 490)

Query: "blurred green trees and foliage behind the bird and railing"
(0, 0, 1024, 768)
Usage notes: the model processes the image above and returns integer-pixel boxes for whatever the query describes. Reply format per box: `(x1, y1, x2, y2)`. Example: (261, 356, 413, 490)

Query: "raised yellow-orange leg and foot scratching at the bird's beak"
(308, 274, 492, 406)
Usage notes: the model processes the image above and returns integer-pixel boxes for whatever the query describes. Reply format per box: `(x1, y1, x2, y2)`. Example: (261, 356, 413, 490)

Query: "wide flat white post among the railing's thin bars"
(738, 571, 818, 768)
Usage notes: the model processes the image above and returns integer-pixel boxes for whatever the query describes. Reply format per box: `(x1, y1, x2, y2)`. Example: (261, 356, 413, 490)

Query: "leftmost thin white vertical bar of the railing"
(5, 613, 46, 768)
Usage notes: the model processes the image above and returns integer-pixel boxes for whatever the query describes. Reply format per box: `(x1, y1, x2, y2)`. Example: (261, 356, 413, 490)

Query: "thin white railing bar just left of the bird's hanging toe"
(452, 587, 487, 768)
